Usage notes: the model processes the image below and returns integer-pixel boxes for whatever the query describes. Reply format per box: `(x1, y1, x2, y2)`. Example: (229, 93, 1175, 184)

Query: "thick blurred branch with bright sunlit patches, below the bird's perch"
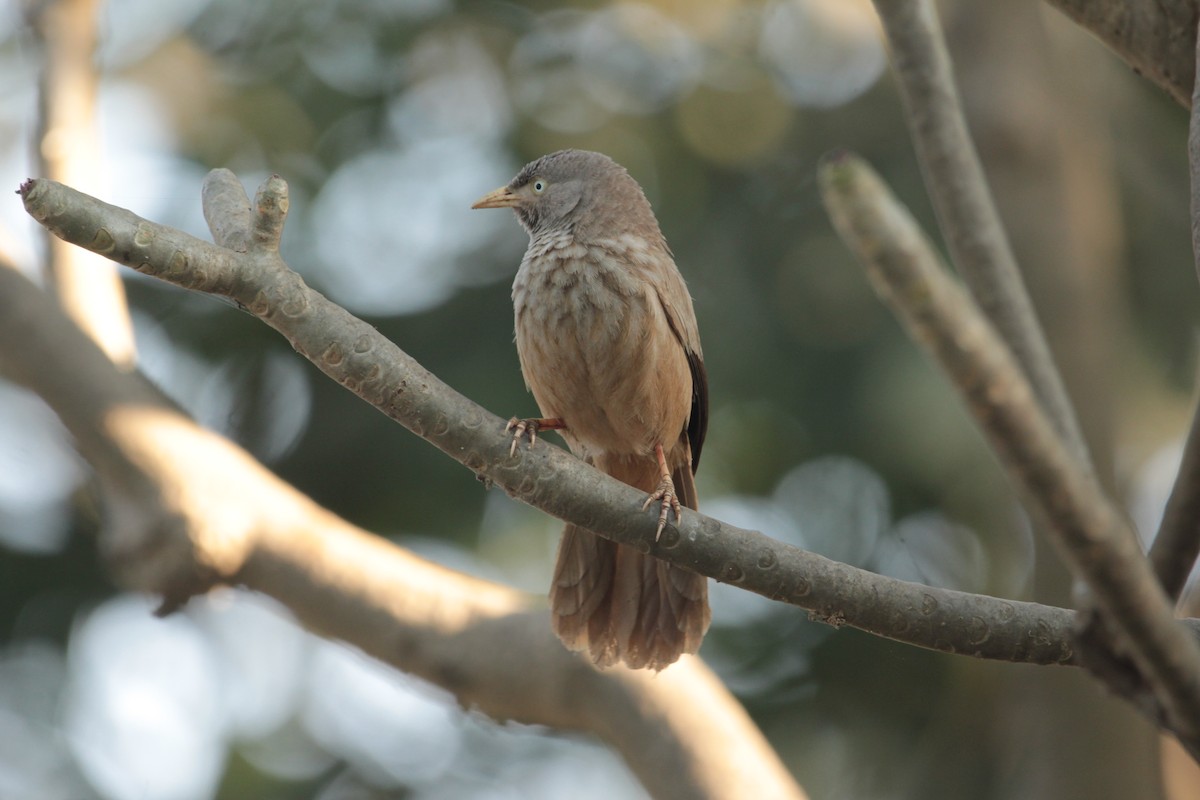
(0, 253, 804, 800)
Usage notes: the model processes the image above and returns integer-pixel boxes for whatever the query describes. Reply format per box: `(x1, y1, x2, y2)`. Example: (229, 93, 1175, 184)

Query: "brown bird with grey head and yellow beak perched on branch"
(472, 150, 712, 672)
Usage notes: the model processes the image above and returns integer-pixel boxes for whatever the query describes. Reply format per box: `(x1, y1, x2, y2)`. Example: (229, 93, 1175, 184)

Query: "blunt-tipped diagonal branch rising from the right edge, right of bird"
(821, 149, 1200, 751)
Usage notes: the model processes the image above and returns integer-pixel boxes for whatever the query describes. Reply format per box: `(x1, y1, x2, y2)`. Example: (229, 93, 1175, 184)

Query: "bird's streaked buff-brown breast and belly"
(512, 236, 691, 455)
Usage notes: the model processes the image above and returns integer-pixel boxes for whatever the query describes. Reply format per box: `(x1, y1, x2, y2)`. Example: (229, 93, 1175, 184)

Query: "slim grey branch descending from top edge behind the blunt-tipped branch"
(875, 0, 1092, 470)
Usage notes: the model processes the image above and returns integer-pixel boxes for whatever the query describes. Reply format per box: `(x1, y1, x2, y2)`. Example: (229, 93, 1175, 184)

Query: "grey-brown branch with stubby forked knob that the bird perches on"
(22, 170, 1089, 664)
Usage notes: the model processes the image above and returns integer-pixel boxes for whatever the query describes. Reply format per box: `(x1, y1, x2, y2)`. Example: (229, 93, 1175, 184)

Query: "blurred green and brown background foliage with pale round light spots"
(0, 0, 1200, 800)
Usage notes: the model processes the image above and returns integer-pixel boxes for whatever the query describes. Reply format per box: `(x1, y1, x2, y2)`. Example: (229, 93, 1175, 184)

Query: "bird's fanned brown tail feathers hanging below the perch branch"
(550, 457, 712, 670)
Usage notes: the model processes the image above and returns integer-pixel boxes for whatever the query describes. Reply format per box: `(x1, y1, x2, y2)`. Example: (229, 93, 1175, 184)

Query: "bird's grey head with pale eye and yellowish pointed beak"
(470, 150, 661, 239)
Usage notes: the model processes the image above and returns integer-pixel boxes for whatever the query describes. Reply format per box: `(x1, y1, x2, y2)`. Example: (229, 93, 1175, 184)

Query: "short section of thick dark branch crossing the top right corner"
(1046, 0, 1200, 108)
